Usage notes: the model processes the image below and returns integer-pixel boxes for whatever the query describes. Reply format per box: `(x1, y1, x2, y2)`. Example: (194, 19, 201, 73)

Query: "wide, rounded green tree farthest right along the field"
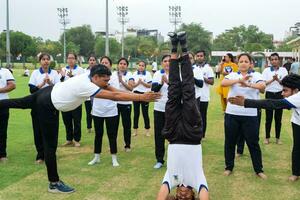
(213, 25, 274, 52)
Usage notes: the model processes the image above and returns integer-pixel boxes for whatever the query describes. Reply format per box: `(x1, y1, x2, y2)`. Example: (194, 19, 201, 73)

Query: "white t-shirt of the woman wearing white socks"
(91, 73, 119, 117)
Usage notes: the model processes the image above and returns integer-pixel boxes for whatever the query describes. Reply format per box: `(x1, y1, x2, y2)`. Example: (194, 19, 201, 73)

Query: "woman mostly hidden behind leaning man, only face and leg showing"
(84, 55, 97, 133)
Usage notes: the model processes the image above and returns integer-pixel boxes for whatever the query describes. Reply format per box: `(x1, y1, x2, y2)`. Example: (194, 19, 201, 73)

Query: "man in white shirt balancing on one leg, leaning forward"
(0, 65, 160, 193)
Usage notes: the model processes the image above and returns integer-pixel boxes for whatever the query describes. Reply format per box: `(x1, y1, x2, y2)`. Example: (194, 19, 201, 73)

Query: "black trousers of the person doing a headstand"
(162, 55, 202, 145)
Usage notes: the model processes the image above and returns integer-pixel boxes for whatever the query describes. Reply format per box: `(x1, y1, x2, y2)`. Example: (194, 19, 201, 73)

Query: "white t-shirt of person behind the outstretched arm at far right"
(262, 66, 288, 92)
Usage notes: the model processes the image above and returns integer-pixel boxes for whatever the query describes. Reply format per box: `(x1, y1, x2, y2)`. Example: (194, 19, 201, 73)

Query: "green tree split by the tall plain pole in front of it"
(94, 36, 121, 61)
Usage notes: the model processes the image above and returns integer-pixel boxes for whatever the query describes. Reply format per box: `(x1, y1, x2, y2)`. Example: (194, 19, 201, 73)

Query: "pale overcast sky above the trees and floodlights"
(0, 0, 300, 40)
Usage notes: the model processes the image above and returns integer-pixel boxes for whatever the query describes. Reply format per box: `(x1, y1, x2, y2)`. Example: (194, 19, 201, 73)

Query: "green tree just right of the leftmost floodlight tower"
(60, 25, 95, 56)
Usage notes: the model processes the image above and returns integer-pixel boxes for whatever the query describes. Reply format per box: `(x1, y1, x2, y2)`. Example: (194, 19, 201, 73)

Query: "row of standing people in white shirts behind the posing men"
(0, 43, 300, 198)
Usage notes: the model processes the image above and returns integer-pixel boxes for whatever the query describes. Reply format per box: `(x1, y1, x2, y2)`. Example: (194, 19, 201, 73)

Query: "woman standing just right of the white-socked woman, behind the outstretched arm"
(113, 58, 134, 152)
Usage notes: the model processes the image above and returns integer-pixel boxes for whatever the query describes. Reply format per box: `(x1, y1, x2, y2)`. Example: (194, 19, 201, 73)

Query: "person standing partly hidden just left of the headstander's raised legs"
(151, 55, 171, 169)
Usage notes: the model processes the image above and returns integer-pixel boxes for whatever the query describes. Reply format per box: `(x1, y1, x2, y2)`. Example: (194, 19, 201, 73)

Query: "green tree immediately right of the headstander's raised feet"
(178, 23, 212, 52)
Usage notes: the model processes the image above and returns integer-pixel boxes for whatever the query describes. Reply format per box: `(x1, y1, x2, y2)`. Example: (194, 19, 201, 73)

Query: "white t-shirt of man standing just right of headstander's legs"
(199, 64, 215, 102)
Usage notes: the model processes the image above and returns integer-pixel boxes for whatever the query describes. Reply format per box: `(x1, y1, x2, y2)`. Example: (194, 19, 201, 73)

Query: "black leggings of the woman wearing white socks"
(93, 116, 118, 154)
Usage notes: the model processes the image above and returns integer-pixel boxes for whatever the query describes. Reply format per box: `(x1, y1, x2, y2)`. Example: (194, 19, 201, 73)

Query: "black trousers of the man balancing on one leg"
(0, 86, 59, 182)
